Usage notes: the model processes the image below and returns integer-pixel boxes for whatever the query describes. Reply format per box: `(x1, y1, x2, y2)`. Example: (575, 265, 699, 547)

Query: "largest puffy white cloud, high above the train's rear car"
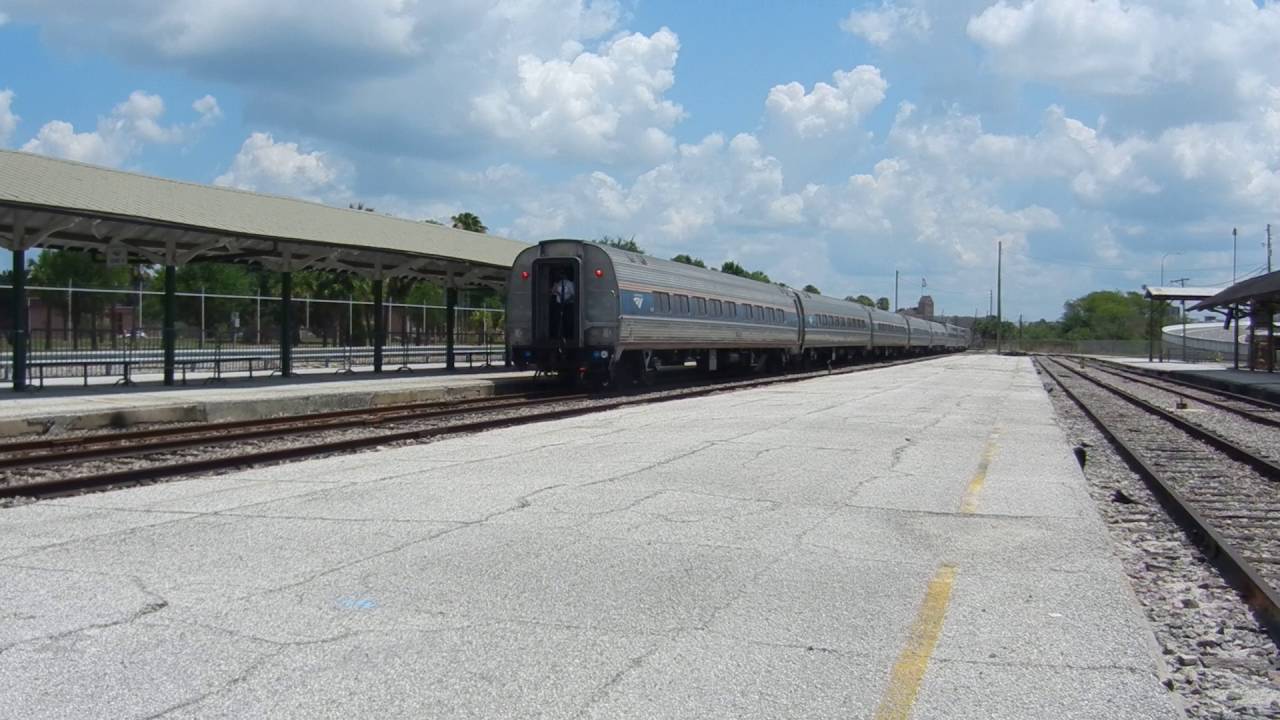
(471, 28, 684, 159)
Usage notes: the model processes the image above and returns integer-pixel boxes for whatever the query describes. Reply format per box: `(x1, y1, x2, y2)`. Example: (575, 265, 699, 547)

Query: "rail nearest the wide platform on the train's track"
(0, 348, 962, 500)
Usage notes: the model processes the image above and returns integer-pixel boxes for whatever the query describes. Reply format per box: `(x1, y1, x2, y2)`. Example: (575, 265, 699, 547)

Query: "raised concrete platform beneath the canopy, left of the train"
(0, 369, 532, 437)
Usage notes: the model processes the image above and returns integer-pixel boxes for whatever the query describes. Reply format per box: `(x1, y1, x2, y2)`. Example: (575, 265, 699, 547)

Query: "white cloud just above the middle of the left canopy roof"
(214, 132, 351, 201)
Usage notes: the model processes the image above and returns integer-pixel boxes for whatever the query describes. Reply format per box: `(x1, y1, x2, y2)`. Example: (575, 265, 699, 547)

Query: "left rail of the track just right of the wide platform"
(1036, 357, 1280, 642)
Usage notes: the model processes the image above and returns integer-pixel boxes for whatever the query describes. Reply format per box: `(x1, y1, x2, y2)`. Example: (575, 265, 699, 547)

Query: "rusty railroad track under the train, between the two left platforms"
(0, 348, 957, 500)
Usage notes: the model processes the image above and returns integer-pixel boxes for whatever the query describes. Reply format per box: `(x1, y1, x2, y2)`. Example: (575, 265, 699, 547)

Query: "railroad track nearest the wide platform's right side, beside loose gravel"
(1037, 357, 1280, 641)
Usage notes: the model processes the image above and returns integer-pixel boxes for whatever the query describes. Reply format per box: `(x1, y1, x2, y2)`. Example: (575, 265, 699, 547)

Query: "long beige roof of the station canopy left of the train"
(0, 150, 526, 288)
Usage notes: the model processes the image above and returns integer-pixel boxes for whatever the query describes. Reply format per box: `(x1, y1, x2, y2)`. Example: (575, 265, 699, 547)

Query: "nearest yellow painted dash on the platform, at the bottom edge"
(876, 565, 956, 720)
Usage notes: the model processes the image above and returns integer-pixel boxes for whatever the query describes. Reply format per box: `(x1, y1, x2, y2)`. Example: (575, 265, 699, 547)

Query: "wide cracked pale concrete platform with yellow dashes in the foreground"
(0, 355, 1180, 719)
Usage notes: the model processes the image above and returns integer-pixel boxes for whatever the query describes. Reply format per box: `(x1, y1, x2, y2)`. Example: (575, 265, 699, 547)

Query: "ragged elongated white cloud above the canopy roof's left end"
(22, 90, 218, 165)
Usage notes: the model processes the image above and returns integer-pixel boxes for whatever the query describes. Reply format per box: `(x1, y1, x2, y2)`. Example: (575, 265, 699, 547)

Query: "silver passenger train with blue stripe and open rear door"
(506, 240, 969, 384)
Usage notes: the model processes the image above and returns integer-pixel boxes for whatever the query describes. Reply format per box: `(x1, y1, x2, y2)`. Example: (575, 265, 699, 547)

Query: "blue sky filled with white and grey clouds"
(0, 0, 1280, 320)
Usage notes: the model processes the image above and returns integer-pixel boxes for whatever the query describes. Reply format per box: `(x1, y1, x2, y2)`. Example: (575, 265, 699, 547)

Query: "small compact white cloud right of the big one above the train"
(764, 65, 888, 138)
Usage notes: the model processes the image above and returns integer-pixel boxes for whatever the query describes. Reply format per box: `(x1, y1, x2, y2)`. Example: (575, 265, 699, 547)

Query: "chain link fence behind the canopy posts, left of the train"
(0, 284, 506, 384)
